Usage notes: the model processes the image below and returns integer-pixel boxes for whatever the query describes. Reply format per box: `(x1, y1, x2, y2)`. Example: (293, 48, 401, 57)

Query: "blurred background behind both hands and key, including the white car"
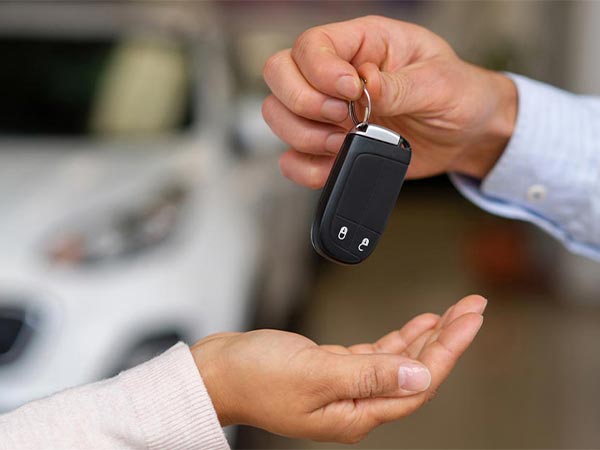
(0, 1, 600, 449)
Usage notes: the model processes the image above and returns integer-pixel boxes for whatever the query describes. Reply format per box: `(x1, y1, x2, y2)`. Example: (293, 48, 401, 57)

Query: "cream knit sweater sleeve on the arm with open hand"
(0, 343, 229, 450)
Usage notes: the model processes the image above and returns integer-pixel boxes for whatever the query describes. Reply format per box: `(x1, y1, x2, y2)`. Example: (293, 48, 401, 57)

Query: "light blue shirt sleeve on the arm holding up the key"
(450, 74, 600, 260)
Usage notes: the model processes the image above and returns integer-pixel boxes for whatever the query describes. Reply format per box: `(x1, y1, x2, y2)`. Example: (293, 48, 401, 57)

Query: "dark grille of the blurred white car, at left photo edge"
(0, 306, 33, 365)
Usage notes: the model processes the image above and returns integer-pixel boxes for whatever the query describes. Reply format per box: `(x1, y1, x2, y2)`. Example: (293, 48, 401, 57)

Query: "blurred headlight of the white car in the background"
(46, 185, 187, 265)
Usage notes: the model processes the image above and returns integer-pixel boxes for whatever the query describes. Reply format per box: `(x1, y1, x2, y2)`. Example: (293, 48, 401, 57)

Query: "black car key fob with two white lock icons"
(311, 124, 412, 264)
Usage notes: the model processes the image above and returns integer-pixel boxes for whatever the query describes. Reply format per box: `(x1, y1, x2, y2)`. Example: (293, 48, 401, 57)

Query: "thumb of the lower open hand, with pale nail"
(324, 354, 431, 400)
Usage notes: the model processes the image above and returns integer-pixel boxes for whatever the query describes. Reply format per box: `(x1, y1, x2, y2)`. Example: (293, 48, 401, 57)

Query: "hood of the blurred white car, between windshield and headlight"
(0, 137, 207, 256)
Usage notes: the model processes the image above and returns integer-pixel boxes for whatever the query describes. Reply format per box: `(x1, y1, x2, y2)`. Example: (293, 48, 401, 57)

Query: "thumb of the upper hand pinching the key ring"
(358, 62, 434, 116)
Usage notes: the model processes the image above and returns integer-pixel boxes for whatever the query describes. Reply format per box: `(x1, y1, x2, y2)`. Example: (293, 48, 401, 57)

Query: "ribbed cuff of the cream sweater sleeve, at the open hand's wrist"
(119, 343, 229, 450)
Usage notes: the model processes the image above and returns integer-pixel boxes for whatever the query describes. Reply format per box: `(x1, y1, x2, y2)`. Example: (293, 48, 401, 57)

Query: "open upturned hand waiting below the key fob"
(192, 295, 486, 443)
